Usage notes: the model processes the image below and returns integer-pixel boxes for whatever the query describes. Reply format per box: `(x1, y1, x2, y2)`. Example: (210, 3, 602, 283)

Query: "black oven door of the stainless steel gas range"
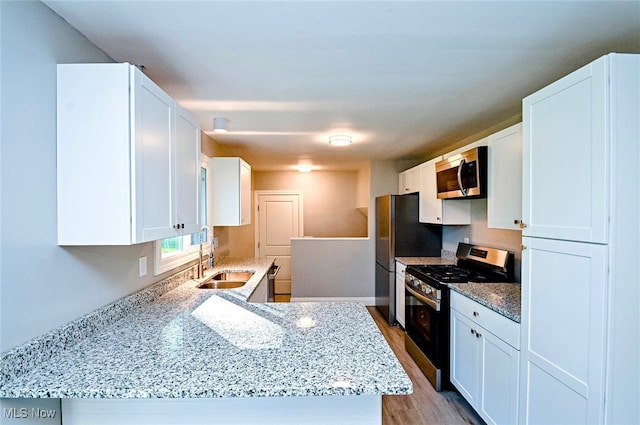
(405, 285, 449, 370)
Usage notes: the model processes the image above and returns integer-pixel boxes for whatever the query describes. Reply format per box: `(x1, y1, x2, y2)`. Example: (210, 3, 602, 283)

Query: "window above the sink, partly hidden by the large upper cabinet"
(153, 155, 208, 275)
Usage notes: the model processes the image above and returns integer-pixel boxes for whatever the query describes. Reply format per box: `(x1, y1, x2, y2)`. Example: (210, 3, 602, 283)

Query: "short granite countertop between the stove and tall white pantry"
(449, 283, 520, 323)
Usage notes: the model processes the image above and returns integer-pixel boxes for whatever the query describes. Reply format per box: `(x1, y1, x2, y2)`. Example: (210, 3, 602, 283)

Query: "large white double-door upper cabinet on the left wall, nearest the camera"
(57, 63, 200, 245)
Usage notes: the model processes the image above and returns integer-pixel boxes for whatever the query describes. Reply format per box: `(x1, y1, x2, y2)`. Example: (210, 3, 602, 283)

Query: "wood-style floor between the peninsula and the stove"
(367, 307, 484, 425)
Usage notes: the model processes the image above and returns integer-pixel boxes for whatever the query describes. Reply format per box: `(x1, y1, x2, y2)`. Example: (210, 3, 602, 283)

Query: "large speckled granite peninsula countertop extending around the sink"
(0, 259, 412, 398)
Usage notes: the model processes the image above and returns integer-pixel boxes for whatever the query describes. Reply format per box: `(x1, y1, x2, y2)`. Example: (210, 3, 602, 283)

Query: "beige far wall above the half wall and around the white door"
(253, 171, 367, 238)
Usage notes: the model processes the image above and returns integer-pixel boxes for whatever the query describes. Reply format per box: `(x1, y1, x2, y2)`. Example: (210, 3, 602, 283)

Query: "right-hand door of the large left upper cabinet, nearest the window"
(174, 105, 201, 234)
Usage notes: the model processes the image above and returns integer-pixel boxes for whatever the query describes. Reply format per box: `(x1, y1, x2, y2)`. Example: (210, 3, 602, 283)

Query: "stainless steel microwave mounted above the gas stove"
(436, 146, 487, 199)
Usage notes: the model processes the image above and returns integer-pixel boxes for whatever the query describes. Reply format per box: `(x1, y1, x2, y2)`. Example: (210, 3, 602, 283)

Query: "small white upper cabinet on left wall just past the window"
(209, 157, 251, 226)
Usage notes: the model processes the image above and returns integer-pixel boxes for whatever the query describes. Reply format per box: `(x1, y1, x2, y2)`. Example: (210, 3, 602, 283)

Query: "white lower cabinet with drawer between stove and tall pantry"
(450, 291, 520, 425)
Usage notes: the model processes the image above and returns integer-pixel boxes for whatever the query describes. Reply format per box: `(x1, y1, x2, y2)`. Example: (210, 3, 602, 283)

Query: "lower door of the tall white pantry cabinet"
(521, 237, 607, 424)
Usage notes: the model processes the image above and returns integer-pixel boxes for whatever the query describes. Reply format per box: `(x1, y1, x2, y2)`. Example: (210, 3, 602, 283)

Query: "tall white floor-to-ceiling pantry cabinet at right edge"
(520, 54, 640, 424)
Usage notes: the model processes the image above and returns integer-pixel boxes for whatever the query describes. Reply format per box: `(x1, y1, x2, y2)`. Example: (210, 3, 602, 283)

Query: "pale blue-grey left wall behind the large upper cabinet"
(0, 1, 172, 352)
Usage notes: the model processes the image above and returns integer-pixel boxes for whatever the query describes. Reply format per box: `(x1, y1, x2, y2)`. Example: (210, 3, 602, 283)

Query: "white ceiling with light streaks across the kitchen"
(44, 0, 640, 170)
